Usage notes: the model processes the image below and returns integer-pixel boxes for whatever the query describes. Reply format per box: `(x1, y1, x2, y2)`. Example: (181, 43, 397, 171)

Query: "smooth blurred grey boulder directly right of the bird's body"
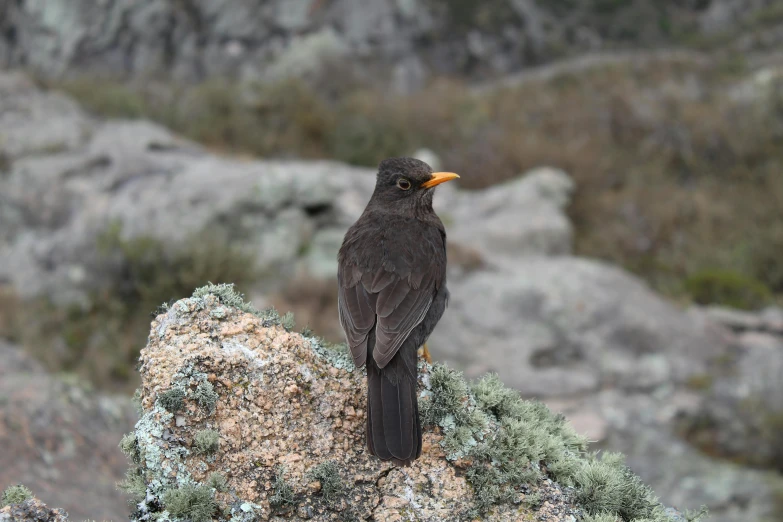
(430, 257, 728, 397)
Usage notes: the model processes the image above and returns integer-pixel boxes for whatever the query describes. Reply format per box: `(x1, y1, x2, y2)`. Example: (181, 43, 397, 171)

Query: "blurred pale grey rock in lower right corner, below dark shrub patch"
(561, 390, 783, 522)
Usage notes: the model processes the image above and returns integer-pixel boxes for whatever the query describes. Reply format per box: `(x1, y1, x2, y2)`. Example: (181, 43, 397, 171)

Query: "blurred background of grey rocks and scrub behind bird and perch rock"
(0, 0, 783, 522)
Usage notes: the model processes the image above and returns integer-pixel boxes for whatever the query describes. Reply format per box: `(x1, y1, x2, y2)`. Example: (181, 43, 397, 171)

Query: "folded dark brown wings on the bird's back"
(338, 221, 446, 368)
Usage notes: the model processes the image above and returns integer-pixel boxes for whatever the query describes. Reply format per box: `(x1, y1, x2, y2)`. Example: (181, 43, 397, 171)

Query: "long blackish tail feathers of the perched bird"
(367, 364, 421, 466)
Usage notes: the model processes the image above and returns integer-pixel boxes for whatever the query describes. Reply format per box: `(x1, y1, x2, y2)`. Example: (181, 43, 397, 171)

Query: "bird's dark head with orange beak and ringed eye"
(372, 158, 459, 209)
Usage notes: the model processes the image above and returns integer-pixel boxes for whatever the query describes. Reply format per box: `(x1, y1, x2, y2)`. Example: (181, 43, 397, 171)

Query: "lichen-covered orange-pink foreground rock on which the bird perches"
(121, 285, 696, 522)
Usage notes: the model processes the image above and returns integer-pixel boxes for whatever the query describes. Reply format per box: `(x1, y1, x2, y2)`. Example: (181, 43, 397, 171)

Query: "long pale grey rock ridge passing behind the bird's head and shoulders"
(0, 73, 573, 306)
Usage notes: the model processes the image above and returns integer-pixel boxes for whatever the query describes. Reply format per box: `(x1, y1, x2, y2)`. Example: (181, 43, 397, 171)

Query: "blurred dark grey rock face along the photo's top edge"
(0, 0, 779, 89)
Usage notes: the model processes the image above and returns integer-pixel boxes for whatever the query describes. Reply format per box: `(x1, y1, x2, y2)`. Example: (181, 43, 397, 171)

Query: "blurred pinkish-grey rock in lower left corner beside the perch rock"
(0, 340, 136, 521)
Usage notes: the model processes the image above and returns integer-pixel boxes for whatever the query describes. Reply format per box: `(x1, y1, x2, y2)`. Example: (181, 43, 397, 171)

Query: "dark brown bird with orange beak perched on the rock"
(337, 158, 459, 466)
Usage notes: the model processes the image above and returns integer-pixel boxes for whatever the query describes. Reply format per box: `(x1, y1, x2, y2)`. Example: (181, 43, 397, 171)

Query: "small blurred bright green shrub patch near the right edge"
(684, 270, 771, 310)
